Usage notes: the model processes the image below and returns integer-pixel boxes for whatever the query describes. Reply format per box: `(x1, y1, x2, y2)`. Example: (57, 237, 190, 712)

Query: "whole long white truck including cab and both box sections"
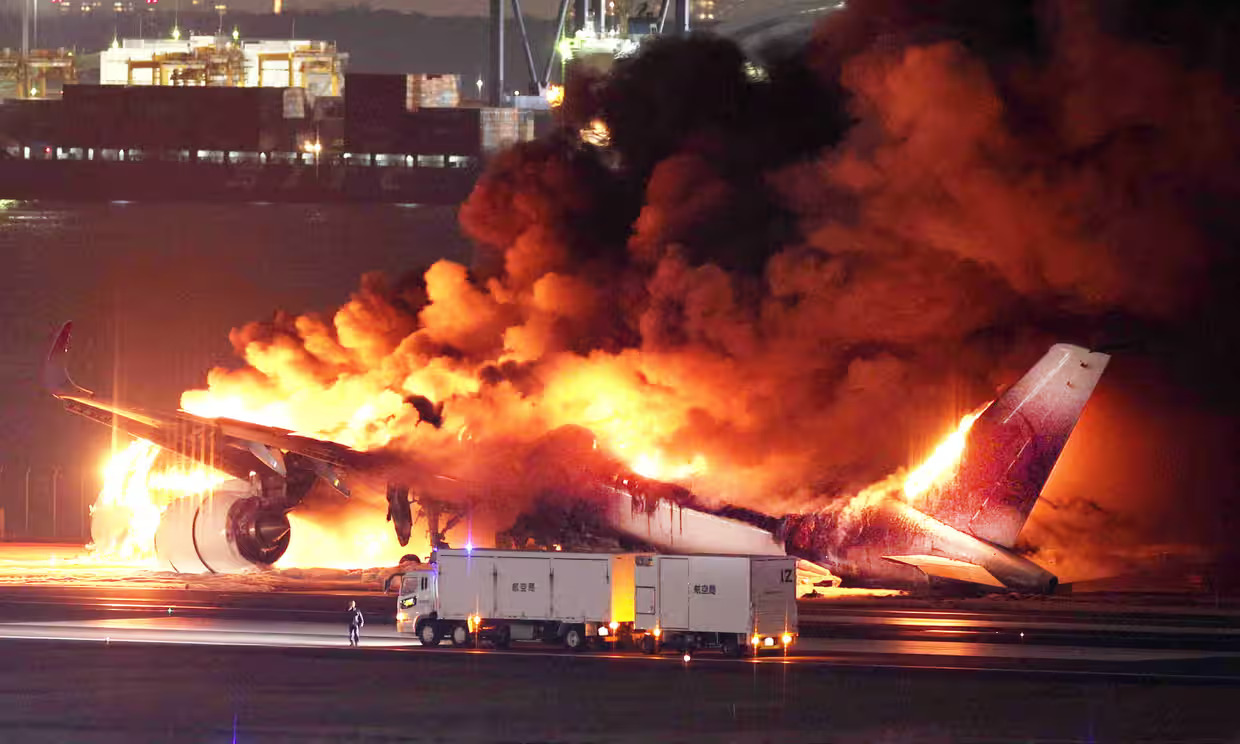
(397, 549, 796, 656)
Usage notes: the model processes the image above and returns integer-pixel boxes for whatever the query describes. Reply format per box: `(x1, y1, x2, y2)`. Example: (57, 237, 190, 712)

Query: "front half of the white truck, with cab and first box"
(397, 548, 634, 650)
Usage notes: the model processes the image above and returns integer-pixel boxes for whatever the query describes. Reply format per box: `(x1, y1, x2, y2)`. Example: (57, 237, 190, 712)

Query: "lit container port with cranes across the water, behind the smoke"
(0, 0, 839, 203)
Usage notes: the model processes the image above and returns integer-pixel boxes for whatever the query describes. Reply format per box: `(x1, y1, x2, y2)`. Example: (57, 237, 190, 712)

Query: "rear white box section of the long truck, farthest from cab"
(632, 554, 796, 656)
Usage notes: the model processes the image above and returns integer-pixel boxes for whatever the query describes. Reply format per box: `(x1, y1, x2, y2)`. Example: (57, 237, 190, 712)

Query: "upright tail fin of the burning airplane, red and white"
(918, 343, 1110, 547)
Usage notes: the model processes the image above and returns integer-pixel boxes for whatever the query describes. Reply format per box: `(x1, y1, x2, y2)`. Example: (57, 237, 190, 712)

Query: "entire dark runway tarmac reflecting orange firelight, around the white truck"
(0, 548, 1240, 744)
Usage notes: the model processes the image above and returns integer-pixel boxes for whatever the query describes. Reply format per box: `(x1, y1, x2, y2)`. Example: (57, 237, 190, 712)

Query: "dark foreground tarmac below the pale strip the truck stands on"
(0, 621, 1240, 744)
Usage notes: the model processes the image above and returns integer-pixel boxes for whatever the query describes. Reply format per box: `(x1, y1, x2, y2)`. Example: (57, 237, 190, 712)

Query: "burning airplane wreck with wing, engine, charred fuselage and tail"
(45, 324, 1109, 591)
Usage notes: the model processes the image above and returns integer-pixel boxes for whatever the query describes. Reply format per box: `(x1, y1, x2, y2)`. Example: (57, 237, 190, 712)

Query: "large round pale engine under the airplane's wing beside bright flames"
(155, 489, 289, 573)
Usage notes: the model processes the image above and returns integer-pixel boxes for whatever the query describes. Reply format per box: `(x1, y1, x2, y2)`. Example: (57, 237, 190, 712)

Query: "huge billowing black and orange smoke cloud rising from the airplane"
(184, 0, 1240, 580)
